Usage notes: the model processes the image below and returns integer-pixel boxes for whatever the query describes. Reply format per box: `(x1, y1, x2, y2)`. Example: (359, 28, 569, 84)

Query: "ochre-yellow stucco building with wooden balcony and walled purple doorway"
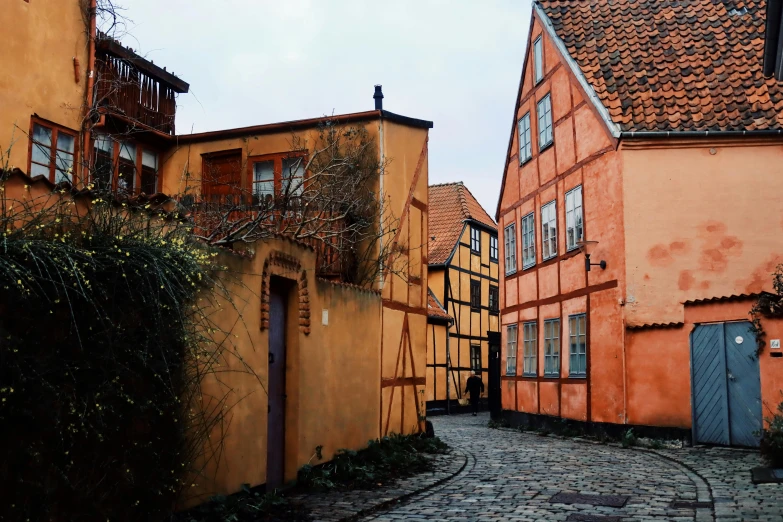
(0, 0, 432, 502)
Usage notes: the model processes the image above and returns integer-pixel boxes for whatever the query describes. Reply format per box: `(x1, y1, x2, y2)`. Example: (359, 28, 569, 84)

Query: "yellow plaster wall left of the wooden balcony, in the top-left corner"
(0, 0, 87, 172)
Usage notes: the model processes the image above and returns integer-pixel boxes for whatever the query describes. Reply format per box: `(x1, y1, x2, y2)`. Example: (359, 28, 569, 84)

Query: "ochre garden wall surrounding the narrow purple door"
(190, 239, 381, 503)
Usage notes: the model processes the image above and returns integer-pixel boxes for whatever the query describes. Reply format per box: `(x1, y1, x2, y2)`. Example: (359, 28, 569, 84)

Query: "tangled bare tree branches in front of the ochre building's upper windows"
(183, 119, 405, 285)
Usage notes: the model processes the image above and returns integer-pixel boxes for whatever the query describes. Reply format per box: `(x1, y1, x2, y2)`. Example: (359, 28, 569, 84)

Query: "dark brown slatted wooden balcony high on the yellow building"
(95, 34, 189, 135)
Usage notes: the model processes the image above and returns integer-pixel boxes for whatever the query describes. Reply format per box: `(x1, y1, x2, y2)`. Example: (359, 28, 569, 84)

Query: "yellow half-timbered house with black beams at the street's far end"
(427, 182, 500, 412)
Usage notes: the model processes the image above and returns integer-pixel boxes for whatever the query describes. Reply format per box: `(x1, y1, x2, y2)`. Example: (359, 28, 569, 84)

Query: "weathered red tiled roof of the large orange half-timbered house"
(537, 0, 783, 131)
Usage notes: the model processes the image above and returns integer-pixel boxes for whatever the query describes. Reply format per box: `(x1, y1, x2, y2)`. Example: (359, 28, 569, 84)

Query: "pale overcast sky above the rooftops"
(118, 0, 531, 218)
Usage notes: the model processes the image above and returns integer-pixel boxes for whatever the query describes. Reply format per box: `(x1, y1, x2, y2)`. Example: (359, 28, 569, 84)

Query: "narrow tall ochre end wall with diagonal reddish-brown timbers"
(379, 120, 429, 435)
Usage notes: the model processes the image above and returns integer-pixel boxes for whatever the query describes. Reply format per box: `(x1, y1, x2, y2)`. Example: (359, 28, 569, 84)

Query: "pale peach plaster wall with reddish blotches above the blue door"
(621, 138, 783, 324)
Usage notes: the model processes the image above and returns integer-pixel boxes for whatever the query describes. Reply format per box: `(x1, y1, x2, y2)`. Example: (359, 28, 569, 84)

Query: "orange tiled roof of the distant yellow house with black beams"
(427, 181, 497, 265)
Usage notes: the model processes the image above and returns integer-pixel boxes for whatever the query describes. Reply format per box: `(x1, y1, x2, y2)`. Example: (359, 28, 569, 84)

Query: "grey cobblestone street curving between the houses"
(362, 414, 783, 522)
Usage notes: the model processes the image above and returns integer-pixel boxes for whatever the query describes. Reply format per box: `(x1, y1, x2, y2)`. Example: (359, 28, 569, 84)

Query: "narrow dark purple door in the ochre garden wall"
(266, 288, 286, 491)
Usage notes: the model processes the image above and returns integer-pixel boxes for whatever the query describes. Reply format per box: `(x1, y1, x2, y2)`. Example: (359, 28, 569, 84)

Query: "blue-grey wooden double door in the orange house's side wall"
(691, 322, 762, 446)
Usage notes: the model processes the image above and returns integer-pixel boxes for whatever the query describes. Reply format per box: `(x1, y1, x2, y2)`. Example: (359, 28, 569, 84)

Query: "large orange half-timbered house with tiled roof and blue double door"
(496, 0, 783, 445)
